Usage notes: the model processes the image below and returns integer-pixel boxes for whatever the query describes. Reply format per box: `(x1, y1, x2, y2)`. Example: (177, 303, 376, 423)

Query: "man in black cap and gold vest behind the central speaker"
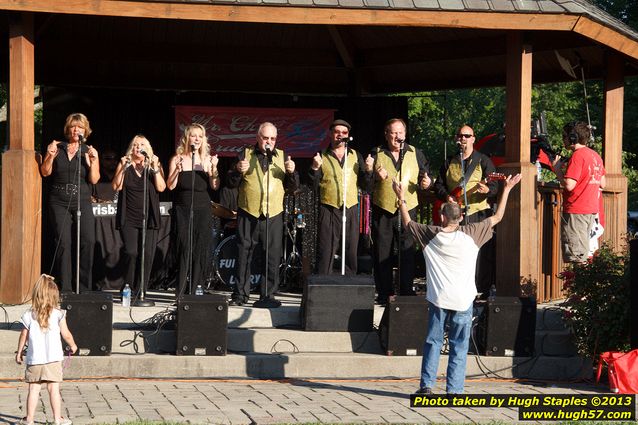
(308, 120, 373, 274)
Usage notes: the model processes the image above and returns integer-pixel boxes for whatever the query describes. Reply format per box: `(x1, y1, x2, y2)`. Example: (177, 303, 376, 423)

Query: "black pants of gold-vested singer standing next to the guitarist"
(372, 205, 416, 303)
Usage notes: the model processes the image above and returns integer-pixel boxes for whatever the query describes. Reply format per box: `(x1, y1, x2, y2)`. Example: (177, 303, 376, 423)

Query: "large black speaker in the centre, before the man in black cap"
(301, 275, 374, 332)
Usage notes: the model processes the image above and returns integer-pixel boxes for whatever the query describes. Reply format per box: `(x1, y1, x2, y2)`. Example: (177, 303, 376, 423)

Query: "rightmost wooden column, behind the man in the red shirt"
(603, 52, 627, 250)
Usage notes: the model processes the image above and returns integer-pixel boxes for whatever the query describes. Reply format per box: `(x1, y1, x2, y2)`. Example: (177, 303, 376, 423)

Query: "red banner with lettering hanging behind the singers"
(175, 106, 334, 158)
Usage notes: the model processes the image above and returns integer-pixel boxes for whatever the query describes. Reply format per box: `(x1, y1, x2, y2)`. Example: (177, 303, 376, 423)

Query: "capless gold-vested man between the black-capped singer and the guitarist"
(372, 118, 431, 304)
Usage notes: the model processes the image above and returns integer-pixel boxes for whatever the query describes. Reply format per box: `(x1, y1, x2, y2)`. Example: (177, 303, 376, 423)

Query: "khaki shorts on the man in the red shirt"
(561, 213, 594, 263)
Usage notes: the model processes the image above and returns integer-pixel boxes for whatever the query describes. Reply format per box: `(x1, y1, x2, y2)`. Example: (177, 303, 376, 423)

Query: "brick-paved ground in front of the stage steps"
(0, 379, 608, 424)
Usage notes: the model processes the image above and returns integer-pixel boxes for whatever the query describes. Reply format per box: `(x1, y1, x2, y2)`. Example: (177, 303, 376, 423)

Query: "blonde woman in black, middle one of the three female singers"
(112, 135, 166, 292)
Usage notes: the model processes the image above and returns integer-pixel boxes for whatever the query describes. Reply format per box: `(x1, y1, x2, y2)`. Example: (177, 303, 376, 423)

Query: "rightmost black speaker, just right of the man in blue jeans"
(477, 297, 536, 357)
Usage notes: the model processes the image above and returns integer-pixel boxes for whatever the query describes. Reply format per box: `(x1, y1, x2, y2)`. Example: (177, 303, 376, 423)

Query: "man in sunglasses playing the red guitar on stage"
(433, 125, 498, 294)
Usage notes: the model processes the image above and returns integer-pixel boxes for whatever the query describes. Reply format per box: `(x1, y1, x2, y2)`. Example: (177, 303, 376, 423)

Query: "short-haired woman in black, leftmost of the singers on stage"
(40, 113, 100, 292)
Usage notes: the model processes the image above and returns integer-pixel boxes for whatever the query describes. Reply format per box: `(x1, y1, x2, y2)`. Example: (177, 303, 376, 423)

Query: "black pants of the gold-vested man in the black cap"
(317, 204, 359, 275)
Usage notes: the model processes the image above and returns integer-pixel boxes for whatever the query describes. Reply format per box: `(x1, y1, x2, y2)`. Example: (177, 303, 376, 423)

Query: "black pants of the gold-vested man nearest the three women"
(232, 209, 284, 302)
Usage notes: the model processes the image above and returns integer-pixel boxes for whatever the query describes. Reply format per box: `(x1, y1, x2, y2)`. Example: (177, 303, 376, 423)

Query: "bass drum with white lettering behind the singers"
(213, 235, 264, 291)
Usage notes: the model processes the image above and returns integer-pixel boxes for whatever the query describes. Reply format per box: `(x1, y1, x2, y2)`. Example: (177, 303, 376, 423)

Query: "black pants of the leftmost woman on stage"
(49, 201, 95, 292)
